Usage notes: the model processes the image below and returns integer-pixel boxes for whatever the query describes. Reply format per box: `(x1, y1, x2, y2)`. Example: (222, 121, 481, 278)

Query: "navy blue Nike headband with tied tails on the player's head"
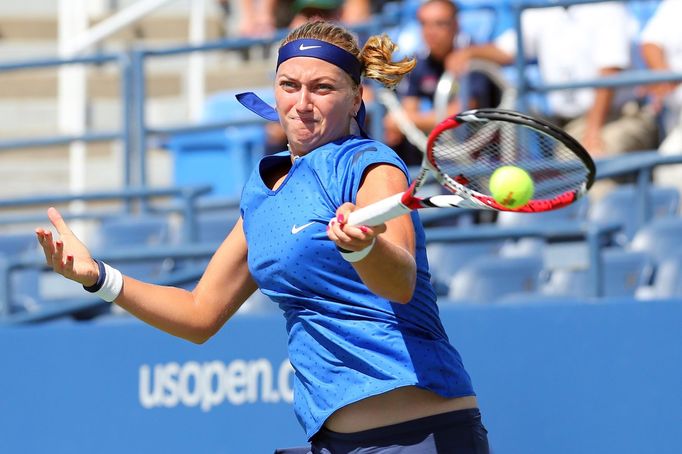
(236, 39, 368, 137)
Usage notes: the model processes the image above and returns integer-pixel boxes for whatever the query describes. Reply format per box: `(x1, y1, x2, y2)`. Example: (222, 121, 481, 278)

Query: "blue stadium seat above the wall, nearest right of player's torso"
(444, 256, 543, 304)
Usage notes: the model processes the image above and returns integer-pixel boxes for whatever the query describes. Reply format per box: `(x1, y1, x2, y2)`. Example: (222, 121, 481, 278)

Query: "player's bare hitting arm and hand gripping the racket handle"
(327, 164, 417, 303)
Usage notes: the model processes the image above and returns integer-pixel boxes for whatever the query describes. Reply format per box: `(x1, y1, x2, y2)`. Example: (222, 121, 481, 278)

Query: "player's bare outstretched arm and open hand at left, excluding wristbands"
(36, 208, 257, 343)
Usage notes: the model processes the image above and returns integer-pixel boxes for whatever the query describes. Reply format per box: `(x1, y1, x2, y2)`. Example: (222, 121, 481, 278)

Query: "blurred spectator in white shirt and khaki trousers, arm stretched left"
(459, 2, 657, 157)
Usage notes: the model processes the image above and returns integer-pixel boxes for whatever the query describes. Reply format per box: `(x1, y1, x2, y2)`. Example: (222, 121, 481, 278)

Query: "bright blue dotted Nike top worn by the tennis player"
(241, 136, 474, 438)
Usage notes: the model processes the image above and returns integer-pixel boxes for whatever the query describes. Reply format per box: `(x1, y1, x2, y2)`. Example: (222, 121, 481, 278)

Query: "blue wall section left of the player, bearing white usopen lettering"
(0, 313, 306, 454)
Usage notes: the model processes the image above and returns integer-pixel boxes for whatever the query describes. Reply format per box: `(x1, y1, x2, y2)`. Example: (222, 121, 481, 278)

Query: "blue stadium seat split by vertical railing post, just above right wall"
(540, 248, 653, 297)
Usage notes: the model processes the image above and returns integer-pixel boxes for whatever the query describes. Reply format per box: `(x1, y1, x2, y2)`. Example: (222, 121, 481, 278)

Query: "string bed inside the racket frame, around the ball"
(429, 121, 589, 200)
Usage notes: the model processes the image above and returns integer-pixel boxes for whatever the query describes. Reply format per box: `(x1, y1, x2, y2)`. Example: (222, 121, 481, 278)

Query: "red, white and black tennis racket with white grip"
(348, 109, 595, 226)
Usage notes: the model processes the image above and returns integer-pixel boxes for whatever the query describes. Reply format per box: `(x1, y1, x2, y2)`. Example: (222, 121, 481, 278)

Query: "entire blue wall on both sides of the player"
(0, 301, 682, 454)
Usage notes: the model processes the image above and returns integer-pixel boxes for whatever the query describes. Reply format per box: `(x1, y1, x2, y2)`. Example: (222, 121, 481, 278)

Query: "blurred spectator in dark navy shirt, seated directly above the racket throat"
(384, 0, 499, 165)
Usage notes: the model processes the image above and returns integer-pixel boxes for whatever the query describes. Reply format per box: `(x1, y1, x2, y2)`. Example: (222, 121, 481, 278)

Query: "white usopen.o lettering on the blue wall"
(139, 358, 294, 411)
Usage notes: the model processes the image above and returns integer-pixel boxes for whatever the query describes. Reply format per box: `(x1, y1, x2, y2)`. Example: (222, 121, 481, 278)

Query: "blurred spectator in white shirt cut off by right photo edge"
(640, 0, 682, 192)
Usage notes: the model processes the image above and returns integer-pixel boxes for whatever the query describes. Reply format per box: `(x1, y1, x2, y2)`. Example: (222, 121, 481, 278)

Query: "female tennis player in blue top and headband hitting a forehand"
(36, 21, 489, 454)
